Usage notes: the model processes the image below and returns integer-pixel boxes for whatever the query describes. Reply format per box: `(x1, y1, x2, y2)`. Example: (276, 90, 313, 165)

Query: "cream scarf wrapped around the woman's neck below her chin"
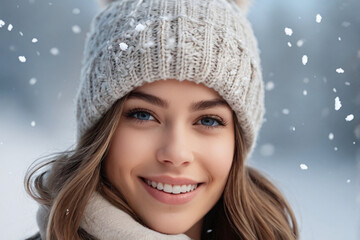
(37, 192, 190, 240)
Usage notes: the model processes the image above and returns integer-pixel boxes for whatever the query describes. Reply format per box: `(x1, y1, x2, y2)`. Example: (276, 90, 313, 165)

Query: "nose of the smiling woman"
(156, 125, 194, 167)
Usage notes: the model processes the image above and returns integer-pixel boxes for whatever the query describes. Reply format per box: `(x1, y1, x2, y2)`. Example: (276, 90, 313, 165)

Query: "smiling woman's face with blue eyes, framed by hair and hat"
(105, 80, 235, 237)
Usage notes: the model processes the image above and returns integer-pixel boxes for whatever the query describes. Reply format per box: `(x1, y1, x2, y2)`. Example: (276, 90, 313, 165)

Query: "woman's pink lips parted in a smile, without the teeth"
(139, 177, 204, 205)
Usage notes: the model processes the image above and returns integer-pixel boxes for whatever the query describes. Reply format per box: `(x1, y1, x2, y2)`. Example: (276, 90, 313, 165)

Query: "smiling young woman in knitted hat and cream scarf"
(26, 0, 298, 240)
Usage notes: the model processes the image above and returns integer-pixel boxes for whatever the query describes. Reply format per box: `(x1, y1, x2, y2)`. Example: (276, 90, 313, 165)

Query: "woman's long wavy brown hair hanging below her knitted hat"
(25, 93, 298, 240)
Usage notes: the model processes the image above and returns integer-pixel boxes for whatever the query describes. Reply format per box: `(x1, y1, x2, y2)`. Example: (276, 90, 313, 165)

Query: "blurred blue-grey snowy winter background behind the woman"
(0, 0, 360, 240)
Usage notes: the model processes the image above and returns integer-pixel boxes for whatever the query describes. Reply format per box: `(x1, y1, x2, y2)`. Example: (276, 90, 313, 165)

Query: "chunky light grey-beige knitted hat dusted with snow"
(76, 0, 264, 152)
